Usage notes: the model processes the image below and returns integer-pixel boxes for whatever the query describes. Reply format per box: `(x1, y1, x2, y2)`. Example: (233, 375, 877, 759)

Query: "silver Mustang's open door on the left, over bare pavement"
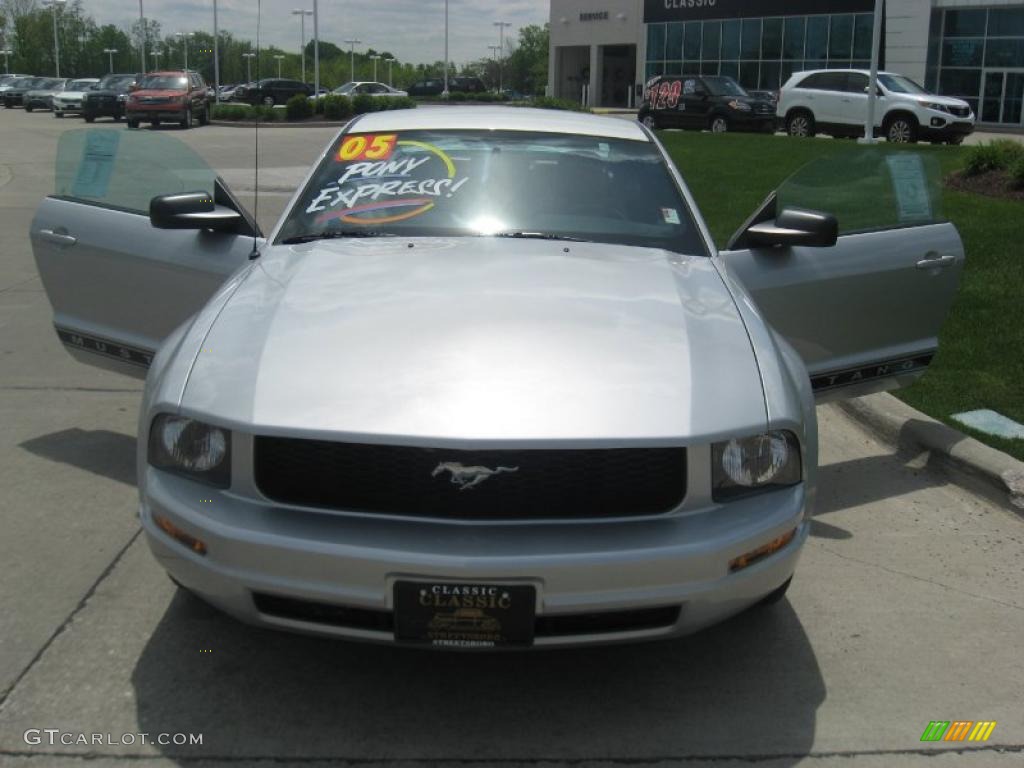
(30, 129, 259, 377)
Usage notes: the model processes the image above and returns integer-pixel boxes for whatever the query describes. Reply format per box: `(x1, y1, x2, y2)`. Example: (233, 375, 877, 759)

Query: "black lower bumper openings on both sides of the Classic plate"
(253, 592, 680, 637)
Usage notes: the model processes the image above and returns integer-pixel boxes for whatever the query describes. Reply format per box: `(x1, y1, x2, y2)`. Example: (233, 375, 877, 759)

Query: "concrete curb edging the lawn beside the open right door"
(837, 392, 1024, 515)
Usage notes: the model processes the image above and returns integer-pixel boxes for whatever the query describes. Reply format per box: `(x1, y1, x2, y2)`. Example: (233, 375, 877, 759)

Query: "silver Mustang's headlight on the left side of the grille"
(148, 414, 231, 488)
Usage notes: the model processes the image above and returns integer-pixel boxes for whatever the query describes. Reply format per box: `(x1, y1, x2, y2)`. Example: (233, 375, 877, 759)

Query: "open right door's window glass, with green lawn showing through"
(776, 146, 945, 234)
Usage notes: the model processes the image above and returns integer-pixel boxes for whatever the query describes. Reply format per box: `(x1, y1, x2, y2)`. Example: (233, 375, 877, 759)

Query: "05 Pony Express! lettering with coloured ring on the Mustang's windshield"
(305, 134, 469, 225)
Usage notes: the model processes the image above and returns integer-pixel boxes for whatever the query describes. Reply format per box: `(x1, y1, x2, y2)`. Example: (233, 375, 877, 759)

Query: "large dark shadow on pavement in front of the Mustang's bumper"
(132, 591, 825, 765)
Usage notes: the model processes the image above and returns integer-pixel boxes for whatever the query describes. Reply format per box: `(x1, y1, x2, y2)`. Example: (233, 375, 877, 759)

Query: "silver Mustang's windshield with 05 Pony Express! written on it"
(278, 130, 707, 254)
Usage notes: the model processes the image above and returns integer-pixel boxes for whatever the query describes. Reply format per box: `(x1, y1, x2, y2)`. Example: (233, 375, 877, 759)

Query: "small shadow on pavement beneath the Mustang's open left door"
(19, 427, 135, 485)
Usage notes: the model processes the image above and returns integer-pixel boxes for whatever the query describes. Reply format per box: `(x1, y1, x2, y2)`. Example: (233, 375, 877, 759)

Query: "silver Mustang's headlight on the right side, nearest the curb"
(712, 431, 803, 502)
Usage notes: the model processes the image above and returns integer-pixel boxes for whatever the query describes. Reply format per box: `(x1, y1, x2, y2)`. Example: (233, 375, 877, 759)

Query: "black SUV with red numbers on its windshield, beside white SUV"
(637, 75, 775, 133)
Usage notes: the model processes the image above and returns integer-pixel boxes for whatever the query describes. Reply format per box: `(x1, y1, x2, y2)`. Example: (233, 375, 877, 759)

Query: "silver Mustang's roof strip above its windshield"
(353, 106, 650, 141)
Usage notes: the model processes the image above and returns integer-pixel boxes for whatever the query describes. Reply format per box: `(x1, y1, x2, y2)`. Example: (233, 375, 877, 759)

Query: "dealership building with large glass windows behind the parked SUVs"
(548, 0, 1024, 128)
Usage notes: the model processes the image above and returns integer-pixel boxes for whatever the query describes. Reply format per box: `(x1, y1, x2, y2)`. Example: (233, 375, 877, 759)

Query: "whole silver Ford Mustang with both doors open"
(31, 108, 964, 648)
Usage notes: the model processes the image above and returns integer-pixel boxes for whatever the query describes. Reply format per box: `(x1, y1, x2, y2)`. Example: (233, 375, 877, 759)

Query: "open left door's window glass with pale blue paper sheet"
(53, 128, 216, 216)
